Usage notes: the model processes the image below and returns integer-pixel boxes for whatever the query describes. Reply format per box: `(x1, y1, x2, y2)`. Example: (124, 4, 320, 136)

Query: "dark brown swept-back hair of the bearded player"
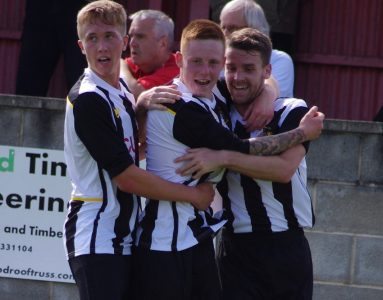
(226, 28, 273, 66)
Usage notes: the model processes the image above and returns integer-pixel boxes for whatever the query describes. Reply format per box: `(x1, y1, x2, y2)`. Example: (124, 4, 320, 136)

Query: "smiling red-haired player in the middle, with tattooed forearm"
(134, 20, 322, 300)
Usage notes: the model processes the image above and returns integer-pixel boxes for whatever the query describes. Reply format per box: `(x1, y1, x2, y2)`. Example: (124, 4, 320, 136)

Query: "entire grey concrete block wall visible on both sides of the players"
(0, 95, 383, 300)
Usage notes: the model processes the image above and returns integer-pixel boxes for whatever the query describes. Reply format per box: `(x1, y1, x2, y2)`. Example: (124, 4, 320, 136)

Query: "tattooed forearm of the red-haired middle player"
(249, 128, 306, 156)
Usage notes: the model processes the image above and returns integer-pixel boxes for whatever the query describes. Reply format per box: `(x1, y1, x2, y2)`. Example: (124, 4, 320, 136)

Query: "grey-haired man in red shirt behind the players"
(121, 10, 179, 99)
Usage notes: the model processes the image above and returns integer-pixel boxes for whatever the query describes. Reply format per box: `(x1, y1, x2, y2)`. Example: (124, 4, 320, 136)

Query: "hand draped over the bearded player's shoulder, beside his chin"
(244, 85, 277, 132)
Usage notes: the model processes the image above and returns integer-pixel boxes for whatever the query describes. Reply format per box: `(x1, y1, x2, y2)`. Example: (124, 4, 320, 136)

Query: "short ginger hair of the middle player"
(181, 19, 225, 53)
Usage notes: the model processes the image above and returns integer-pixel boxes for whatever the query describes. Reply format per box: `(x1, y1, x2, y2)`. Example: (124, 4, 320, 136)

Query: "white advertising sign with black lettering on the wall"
(0, 145, 74, 282)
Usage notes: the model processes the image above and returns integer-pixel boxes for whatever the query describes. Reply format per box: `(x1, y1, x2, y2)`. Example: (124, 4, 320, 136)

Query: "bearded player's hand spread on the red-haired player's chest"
(174, 148, 222, 179)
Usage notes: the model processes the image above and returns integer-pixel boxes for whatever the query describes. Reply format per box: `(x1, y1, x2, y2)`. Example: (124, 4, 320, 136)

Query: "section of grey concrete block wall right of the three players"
(307, 120, 383, 300)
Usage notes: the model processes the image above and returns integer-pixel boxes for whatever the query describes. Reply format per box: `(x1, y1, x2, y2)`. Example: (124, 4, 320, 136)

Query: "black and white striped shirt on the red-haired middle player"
(137, 79, 249, 251)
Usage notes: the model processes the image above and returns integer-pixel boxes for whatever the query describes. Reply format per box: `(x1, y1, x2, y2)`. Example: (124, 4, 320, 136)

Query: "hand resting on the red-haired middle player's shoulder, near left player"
(137, 85, 182, 110)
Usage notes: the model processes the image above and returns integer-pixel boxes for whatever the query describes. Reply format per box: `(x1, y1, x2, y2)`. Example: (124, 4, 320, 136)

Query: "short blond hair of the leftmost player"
(77, 0, 127, 39)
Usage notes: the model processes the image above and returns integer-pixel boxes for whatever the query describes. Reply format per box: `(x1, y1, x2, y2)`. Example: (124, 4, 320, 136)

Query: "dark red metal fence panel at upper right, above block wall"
(294, 0, 383, 120)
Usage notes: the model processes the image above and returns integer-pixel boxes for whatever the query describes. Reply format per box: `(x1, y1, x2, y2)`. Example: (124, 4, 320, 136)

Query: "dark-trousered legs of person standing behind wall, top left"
(16, 0, 88, 97)
